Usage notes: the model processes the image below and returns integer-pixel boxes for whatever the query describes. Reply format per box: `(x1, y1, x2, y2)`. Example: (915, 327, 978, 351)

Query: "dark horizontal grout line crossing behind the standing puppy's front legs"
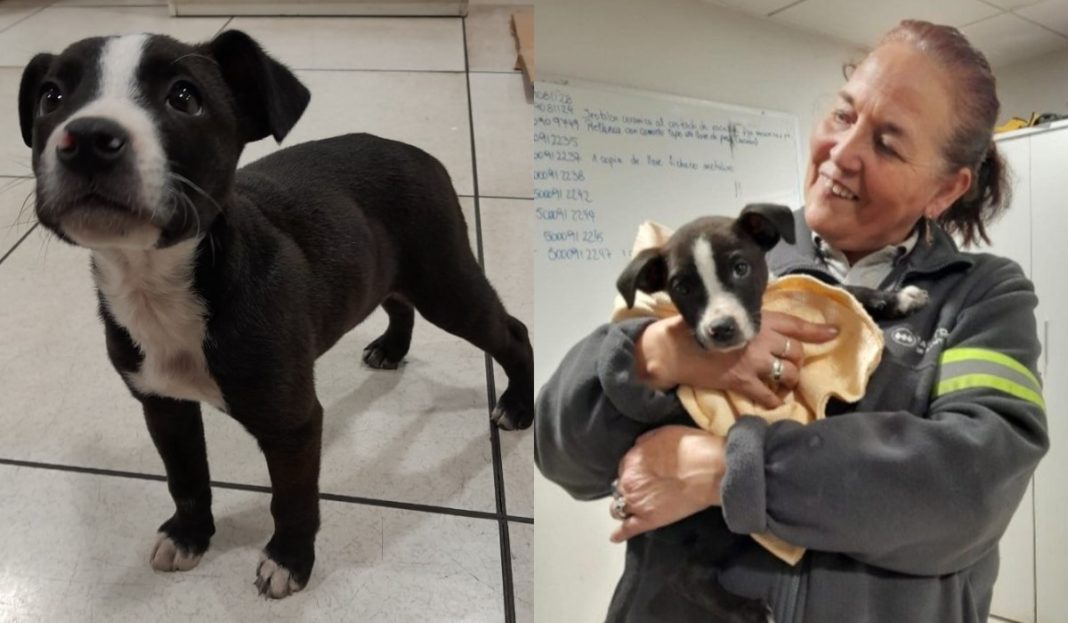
(0, 458, 534, 524)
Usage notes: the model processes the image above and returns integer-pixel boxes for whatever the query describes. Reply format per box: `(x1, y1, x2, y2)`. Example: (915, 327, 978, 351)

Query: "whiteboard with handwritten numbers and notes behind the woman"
(534, 79, 801, 387)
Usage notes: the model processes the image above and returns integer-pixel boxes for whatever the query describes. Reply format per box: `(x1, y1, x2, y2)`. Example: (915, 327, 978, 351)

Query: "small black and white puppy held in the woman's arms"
(616, 203, 927, 623)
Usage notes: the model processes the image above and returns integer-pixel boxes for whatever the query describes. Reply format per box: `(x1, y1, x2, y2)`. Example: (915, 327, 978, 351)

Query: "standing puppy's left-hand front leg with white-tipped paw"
(141, 396, 215, 571)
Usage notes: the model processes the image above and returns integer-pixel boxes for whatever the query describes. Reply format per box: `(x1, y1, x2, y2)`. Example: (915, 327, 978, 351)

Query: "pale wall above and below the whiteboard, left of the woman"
(534, 0, 863, 622)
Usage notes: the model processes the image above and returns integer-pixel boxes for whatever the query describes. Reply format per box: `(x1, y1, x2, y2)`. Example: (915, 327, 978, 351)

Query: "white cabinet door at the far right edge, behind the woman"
(1031, 129, 1068, 623)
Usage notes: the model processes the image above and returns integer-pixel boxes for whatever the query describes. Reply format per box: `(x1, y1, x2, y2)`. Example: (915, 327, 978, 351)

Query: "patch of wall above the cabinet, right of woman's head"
(994, 50, 1068, 123)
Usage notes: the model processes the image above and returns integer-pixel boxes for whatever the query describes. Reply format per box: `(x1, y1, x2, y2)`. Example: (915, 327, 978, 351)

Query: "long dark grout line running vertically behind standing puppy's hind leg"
(460, 17, 516, 623)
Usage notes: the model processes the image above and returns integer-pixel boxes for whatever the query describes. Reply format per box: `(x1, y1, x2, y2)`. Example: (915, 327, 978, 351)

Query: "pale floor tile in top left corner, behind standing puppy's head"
(0, 6, 226, 67)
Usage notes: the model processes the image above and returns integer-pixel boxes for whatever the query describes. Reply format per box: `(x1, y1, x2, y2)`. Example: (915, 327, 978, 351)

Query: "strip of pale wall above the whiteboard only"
(535, 0, 864, 182)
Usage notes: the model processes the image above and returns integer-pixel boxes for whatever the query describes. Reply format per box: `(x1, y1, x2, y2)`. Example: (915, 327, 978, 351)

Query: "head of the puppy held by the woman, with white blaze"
(617, 204, 794, 351)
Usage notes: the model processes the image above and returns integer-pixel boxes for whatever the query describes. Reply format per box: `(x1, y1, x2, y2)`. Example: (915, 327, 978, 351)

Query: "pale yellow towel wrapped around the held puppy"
(612, 221, 883, 564)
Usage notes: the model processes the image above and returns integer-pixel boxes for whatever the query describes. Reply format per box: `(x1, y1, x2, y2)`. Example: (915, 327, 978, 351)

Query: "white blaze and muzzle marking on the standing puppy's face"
(41, 34, 170, 231)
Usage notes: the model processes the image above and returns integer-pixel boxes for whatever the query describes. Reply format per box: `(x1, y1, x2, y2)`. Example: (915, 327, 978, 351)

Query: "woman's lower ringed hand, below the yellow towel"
(612, 426, 724, 543)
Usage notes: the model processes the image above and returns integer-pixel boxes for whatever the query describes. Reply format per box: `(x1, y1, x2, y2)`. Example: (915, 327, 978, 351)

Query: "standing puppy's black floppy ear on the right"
(208, 30, 311, 142)
